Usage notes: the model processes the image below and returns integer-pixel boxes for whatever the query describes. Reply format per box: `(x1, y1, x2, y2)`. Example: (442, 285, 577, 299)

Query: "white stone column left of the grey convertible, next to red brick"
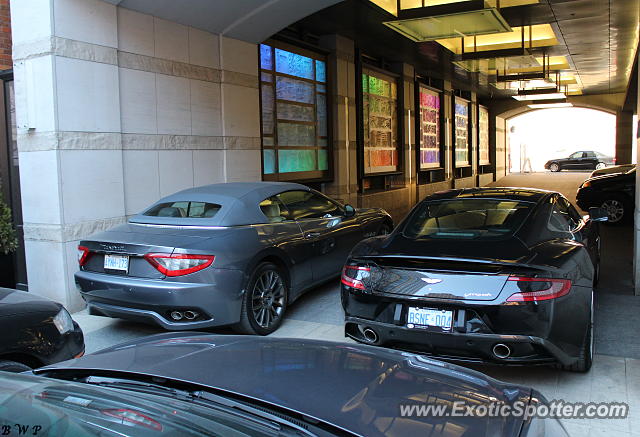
(11, 0, 125, 311)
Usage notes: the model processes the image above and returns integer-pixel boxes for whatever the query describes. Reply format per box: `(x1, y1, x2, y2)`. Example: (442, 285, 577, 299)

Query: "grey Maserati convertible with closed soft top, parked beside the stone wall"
(75, 182, 393, 335)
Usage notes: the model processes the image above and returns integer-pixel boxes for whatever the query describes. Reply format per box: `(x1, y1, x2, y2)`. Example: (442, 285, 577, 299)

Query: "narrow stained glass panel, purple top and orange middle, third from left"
(420, 87, 440, 169)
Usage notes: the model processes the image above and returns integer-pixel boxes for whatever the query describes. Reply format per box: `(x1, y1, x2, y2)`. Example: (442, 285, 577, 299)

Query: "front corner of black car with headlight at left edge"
(0, 288, 84, 372)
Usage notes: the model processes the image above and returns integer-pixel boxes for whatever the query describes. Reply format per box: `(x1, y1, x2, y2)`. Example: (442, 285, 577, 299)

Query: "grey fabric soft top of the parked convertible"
(129, 182, 310, 226)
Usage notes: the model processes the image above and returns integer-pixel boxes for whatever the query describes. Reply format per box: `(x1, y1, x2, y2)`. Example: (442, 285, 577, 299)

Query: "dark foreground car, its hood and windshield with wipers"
(21, 332, 567, 437)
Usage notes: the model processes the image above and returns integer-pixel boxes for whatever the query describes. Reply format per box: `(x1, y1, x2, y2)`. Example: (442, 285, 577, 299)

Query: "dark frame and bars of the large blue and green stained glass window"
(257, 39, 334, 183)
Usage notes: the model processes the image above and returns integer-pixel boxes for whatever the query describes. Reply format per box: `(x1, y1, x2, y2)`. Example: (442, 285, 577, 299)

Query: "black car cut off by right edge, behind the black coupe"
(576, 166, 636, 224)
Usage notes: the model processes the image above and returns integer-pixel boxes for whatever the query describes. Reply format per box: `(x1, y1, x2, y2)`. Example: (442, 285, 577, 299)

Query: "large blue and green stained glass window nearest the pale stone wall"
(260, 44, 329, 180)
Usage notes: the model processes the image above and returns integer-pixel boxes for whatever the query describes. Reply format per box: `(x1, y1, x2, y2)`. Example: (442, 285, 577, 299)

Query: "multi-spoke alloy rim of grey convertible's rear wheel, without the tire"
(251, 270, 285, 330)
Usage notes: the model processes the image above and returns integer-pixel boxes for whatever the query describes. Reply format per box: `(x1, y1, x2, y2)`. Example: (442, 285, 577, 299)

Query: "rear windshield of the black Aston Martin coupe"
(403, 199, 534, 239)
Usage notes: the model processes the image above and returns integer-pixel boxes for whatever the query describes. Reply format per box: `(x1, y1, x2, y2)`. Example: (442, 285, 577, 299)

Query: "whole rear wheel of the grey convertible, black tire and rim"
(233, 262, 289, 335)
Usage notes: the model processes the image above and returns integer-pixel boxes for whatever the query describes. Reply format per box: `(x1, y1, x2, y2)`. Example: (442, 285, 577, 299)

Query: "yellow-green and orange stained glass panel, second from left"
(362, 70, 398, 174)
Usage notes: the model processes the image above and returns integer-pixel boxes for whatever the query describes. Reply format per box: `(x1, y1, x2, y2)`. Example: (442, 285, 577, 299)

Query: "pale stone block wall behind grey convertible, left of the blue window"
(11, 0, 261, 311)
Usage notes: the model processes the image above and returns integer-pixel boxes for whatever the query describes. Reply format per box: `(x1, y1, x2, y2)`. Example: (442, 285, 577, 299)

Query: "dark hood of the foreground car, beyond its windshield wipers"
(35, 333, 532, 437)
